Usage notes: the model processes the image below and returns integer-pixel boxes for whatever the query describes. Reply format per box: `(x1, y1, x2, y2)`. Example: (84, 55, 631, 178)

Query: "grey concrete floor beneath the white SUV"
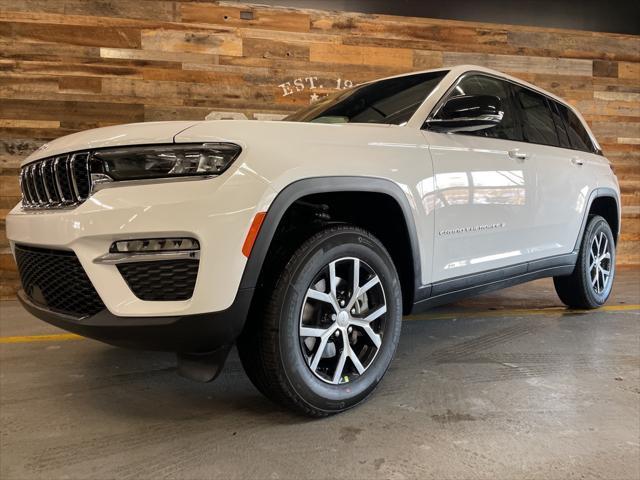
(0, 270, 640, 479)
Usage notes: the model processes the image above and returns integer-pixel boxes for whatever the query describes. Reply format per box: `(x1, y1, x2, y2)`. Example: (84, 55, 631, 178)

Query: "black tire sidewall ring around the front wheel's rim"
(278, 229, 402, 412)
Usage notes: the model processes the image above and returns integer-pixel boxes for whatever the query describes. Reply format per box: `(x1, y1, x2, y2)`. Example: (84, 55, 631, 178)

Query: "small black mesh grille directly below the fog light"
(118, 260, 199, 301)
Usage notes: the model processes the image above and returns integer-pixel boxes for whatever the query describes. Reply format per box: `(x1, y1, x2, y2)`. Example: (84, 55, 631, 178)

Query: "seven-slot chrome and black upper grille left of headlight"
(20, 152, 91, 208)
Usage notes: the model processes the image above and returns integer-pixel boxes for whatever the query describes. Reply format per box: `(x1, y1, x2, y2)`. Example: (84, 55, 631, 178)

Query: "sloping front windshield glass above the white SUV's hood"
(284, 70, 447, 125)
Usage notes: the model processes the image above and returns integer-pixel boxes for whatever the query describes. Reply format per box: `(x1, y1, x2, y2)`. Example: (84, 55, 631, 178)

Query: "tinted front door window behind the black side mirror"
(442, 75, 522, 141)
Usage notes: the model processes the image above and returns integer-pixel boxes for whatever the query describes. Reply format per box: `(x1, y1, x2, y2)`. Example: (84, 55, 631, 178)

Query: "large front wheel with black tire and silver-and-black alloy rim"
(238, 226, 402, 417)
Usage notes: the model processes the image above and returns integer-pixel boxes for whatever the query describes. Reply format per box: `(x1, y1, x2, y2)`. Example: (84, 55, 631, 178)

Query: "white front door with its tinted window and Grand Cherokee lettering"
(423, 74, 536, 282)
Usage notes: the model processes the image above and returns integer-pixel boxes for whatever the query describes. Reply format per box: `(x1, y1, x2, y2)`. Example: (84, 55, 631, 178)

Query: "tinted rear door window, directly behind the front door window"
(513, 85, 559, 146)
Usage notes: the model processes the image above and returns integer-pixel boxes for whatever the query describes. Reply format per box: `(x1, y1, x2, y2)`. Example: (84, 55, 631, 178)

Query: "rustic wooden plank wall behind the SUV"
(0, 0, 640, 298)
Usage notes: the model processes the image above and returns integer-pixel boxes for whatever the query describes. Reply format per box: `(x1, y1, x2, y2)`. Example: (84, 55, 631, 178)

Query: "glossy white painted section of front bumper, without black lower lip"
(7, 165, 270, 316)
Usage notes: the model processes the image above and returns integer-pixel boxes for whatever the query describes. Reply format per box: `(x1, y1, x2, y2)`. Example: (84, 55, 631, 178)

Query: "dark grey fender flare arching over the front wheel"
(240, 176, 422, 298)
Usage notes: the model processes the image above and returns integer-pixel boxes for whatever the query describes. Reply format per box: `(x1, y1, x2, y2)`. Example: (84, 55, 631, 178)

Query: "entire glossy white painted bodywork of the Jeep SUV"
(7, 66, 618, 316)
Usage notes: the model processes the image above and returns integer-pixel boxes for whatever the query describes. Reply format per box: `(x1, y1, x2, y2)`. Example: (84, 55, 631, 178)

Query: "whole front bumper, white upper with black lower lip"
(7, 168, 269, 352)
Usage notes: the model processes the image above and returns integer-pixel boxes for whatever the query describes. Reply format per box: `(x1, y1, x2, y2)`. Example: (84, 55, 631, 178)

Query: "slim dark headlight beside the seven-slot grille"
(91, 143, 241, 183)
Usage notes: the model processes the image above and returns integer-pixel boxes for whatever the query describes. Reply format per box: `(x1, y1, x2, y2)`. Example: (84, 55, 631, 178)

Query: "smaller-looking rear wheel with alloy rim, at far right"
(553, 215, 616, 308)
